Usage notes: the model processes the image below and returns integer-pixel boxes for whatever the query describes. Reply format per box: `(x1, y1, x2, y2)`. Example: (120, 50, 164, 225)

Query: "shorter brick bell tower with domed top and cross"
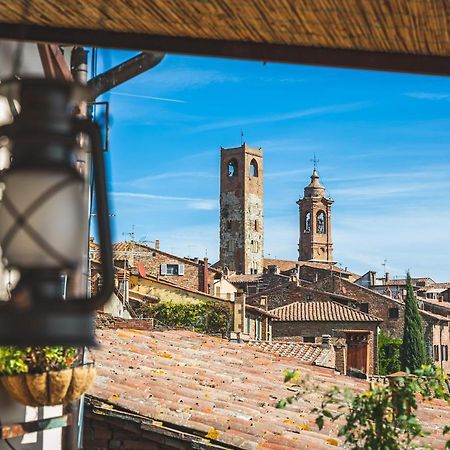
(297, 164, 333, 262)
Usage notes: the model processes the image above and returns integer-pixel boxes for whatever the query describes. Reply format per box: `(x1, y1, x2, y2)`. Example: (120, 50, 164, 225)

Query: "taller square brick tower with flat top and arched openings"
(220, 143, 264, 274)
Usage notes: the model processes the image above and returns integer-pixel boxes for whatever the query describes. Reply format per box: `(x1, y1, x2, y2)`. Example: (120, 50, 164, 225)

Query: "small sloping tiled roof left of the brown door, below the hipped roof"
(249, 341, 335, 369)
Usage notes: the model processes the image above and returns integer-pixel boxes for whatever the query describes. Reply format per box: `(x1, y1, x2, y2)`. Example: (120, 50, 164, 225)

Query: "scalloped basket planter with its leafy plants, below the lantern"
(0, 346, 95, 406)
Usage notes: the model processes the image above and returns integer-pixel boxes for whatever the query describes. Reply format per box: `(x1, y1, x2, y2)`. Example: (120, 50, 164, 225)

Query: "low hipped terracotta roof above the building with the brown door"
(271, 301, 382, 322)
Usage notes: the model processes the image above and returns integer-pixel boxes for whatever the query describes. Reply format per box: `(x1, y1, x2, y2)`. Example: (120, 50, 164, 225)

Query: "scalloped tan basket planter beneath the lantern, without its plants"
(0, 364, 95, 406)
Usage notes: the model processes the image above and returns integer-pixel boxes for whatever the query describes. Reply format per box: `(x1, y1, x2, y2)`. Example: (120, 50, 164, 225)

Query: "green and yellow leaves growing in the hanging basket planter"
(0, 346, 79, 375)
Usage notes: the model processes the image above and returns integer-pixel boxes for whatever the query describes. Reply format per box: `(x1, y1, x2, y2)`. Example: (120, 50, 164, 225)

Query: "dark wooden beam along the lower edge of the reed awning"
(0, 23, 450, 76)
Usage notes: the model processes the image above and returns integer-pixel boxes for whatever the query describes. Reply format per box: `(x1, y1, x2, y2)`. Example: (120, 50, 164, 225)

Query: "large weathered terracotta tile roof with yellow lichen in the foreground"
(88, 329, 450, 450)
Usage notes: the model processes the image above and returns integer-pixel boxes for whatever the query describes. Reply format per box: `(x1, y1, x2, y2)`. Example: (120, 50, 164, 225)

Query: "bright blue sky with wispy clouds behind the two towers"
(93, 50, 450, 281)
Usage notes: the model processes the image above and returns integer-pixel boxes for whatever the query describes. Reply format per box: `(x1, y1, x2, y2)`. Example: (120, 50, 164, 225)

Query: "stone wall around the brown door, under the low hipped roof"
(272, 321, 378, 374)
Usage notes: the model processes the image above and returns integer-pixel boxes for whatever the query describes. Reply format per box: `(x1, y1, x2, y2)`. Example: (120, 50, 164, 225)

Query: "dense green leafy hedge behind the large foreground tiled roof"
(144, 302, 230, 333)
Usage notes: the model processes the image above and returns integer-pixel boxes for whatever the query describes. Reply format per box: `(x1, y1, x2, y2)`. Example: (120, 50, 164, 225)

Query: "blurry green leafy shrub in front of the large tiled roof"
(277, 366, 450, 450)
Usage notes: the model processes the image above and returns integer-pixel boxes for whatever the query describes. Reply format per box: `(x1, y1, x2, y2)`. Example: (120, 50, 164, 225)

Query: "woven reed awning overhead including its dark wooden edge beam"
(0, 0, 450, 75)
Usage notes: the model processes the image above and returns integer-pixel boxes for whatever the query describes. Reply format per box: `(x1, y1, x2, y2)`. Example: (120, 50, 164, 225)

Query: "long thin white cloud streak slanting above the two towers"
(191, 102, 368, 132)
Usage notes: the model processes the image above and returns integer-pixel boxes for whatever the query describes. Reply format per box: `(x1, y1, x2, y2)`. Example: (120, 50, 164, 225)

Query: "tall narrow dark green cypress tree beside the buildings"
(400, 272, 427, 372)
